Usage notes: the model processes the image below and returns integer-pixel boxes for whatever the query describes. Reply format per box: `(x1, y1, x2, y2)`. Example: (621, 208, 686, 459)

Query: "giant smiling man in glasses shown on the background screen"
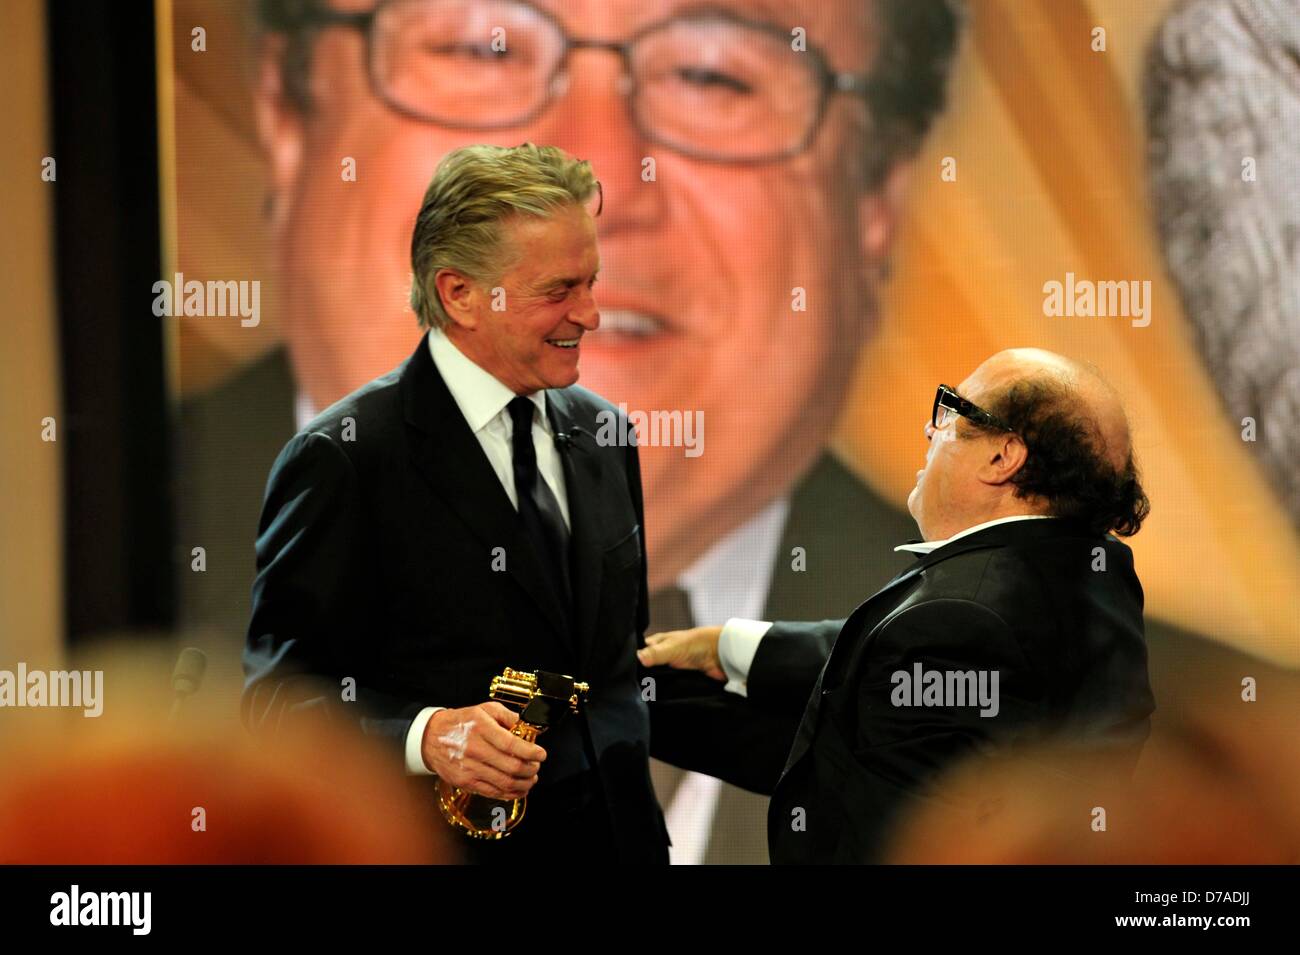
(176, 0, 1279, 861)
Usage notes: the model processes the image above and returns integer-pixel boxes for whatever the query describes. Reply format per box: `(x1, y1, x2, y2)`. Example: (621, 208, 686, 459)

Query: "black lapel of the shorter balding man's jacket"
(777, 518, 1086, 785)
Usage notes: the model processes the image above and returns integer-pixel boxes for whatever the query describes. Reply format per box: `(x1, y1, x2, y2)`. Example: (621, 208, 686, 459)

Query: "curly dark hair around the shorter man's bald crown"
(962, 378, 1151, 537)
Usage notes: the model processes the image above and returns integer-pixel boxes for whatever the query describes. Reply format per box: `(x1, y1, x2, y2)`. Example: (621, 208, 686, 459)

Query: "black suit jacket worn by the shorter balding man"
(749, 518, 1154, 863)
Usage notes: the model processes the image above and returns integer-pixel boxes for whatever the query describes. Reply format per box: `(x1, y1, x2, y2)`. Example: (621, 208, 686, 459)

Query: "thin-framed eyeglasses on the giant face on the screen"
(299, 0, 872, 162)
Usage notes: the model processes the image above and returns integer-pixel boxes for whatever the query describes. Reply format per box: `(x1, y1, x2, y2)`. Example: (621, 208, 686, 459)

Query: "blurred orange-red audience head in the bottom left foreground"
(0, 654, 455, 864)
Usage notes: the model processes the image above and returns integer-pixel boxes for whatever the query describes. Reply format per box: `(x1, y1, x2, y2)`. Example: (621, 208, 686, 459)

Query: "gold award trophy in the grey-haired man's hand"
(438, 667, 590, 839)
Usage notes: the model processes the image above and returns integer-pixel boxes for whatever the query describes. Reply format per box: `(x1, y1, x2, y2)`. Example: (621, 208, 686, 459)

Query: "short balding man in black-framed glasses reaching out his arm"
(641, 350, 1154, 863)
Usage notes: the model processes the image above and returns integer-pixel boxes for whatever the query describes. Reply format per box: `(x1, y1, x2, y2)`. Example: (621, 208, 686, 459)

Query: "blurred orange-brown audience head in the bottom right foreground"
(888, 676, 1300, 865)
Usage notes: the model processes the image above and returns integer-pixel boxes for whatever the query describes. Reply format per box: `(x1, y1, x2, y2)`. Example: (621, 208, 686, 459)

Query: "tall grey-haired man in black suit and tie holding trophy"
(244, 144, 668, 863)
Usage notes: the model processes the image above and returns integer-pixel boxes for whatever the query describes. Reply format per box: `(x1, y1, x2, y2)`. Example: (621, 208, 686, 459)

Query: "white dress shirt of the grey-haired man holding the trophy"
(406, 329, 569, 776)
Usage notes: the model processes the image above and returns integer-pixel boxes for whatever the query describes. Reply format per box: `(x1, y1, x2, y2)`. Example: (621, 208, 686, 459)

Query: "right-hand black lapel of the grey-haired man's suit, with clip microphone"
(546, 388, 605, 672)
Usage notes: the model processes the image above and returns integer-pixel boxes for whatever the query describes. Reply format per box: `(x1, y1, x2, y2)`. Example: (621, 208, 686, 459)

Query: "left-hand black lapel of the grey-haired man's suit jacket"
(399, 335, 572, 643)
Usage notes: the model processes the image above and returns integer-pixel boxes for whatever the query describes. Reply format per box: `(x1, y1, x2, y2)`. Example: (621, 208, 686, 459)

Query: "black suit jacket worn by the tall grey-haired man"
(243, 339, 667, 861)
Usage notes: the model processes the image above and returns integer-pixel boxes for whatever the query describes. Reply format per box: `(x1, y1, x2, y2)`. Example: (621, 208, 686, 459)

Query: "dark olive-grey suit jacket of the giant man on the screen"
(185, 348, 1278, 861)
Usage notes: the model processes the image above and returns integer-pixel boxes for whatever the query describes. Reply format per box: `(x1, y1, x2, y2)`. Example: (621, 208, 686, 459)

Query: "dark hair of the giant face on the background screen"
(252, 0, 965, 185)
